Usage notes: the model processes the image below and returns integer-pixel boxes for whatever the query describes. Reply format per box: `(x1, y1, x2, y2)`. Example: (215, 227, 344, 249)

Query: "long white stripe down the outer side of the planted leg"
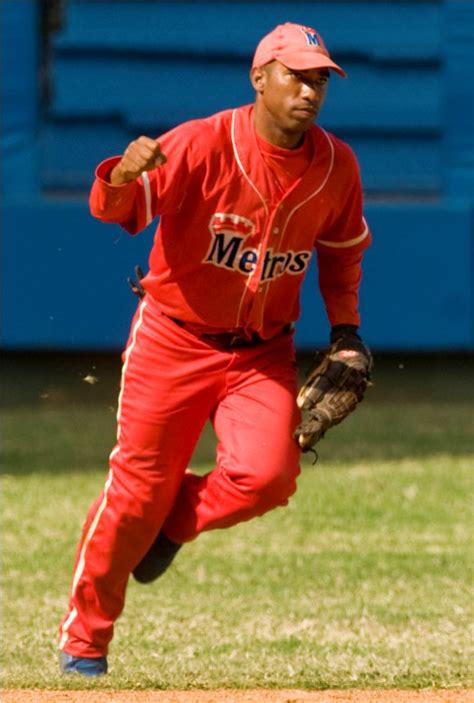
(59, 301, 146, 649)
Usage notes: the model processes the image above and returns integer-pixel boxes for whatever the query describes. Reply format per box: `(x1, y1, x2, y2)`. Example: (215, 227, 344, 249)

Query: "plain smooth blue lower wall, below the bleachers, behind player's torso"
(2, 201, 473, 350)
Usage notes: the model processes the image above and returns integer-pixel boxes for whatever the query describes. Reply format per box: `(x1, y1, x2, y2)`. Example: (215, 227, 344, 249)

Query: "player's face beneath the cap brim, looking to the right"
(252, 61, 329, 146)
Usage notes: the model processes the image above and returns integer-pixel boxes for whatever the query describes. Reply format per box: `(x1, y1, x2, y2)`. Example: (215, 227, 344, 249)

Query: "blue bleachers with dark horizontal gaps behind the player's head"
(42, 0, 443, 191)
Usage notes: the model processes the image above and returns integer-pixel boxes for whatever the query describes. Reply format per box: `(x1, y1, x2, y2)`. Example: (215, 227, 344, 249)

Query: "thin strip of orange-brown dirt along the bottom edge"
(0, 689, 474, 703)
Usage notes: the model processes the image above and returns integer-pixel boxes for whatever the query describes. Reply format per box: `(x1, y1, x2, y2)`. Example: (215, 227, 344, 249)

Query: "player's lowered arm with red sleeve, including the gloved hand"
(294, 146, 372, 451)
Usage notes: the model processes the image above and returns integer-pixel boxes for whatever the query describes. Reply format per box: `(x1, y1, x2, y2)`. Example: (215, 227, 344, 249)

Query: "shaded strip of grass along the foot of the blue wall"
(0, 352, 474, 475)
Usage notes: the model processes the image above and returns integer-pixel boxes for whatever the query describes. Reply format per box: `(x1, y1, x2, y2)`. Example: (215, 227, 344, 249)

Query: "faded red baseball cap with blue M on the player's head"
(252, 22, 346, 78)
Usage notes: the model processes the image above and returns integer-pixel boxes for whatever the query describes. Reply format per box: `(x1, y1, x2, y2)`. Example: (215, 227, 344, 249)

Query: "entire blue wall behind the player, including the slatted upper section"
(1, 0, 474, 350)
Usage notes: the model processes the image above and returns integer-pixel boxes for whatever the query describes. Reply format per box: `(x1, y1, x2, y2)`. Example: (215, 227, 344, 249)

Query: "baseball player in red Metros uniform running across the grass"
(60, 23, 370, 676)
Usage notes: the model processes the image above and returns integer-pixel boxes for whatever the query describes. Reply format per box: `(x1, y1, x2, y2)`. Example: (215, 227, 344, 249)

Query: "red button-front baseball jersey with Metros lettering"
(90, 105, 370, 339)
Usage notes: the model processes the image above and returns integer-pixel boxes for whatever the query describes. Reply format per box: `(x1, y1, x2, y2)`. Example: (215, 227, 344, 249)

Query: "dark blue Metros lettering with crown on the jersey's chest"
(203, 212, 311, 281)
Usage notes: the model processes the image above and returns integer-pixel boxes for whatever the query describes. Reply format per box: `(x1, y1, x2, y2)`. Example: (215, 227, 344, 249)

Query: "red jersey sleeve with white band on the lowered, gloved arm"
(316, 143, 371, 326)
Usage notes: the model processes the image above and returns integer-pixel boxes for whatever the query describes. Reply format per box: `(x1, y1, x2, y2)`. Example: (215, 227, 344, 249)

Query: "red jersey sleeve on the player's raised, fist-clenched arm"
(89, 123, 204, 234)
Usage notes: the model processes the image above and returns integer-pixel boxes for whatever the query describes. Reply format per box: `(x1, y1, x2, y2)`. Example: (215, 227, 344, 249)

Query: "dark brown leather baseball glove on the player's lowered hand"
(293, 325, 372, 452)
